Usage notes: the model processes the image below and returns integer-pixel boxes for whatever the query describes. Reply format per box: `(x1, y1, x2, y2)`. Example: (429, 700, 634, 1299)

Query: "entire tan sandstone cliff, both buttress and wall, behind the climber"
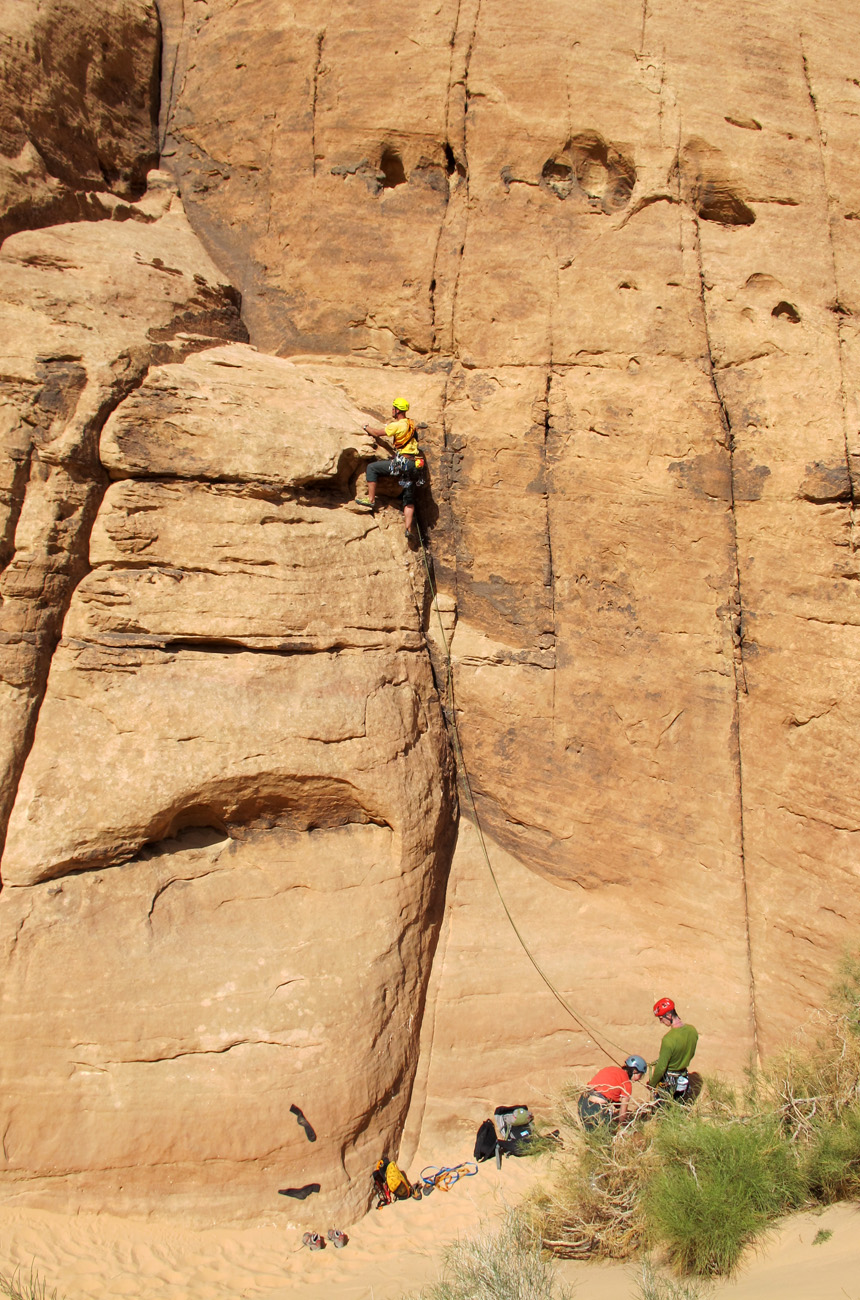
(0, 0, 860, 1213)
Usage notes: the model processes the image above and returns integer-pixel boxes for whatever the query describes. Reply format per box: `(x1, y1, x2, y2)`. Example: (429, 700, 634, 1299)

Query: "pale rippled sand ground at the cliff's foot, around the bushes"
(0, 1160, 860, 1300)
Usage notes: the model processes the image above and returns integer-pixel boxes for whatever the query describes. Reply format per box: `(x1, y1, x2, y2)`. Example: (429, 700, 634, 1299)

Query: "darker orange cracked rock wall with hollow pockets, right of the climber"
(161, 0, 860, 1069)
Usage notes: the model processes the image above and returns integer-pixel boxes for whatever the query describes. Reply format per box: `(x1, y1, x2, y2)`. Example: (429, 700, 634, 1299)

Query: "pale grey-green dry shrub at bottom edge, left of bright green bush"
(420, 1213, 569, 1300)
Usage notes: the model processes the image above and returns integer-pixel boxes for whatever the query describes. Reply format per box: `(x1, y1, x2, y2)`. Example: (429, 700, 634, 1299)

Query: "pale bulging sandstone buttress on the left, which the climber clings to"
(0, 4, 455, 1223)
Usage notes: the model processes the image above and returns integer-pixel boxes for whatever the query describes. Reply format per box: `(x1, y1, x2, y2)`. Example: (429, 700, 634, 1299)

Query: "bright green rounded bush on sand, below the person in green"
(643, 1110, 807, 1275)
